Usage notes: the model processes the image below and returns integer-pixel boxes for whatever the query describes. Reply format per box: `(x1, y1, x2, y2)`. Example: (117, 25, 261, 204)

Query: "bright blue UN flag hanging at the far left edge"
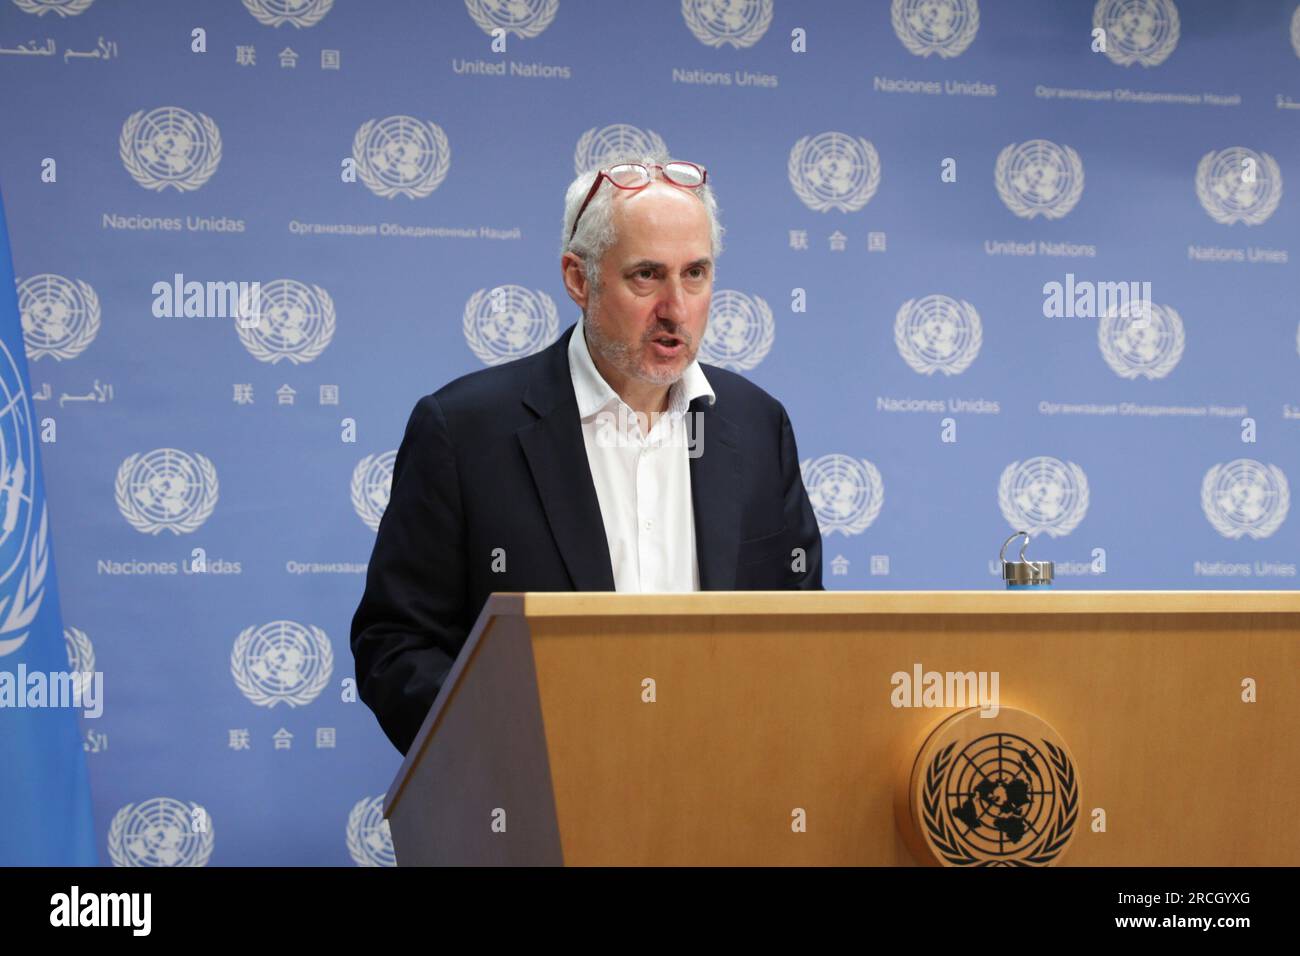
(0, 188, 103, 866)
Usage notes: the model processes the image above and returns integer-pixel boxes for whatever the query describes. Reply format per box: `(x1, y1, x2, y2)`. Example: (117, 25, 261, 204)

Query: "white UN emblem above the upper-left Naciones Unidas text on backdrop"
(117, 107, 221, 193)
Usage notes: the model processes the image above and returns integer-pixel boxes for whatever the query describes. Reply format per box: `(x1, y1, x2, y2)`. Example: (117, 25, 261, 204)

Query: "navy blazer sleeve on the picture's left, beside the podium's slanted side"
(351, 395, 468, 754)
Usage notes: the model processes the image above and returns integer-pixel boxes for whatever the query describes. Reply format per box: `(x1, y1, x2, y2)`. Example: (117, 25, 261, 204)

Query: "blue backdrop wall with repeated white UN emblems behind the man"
(0, 0, 1300, 865)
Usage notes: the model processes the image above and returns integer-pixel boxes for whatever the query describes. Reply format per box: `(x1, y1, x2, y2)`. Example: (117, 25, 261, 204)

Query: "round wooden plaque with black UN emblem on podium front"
(897, 708, 1079, 866)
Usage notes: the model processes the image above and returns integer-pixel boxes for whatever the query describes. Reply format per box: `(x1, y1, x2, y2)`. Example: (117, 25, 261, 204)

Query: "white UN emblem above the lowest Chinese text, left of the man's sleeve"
(230, 620, 334, 708)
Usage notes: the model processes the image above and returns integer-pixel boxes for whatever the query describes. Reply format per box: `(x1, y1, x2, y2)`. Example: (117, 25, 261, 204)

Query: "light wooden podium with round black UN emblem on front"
(385, 591, 1300, 866)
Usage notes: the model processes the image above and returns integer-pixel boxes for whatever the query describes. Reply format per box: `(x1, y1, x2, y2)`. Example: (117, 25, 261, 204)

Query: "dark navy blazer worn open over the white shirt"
(351, 325, 823, 753)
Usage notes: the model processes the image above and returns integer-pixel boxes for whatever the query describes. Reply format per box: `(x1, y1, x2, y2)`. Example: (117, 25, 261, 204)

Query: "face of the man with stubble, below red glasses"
(585, 181, 714, 385)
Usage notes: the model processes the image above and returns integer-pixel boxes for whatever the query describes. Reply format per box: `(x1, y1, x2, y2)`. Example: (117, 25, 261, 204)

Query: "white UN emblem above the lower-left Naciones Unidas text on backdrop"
(113, 449, 217, 535)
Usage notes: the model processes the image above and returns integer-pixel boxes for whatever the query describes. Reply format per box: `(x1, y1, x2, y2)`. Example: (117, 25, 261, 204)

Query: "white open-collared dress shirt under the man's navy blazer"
(568, 317, 718, 592)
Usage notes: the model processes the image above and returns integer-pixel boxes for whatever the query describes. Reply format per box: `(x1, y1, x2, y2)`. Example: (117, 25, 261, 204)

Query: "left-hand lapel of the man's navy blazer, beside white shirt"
(516, 325, 614, 591)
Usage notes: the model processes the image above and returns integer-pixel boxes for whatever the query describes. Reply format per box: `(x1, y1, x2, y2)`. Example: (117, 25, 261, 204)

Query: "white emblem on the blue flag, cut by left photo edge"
(0, 341, 49, 657)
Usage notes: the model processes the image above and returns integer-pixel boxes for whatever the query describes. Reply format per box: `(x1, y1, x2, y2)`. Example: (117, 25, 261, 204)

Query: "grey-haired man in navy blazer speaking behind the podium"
(352, 157, 822, 753)
